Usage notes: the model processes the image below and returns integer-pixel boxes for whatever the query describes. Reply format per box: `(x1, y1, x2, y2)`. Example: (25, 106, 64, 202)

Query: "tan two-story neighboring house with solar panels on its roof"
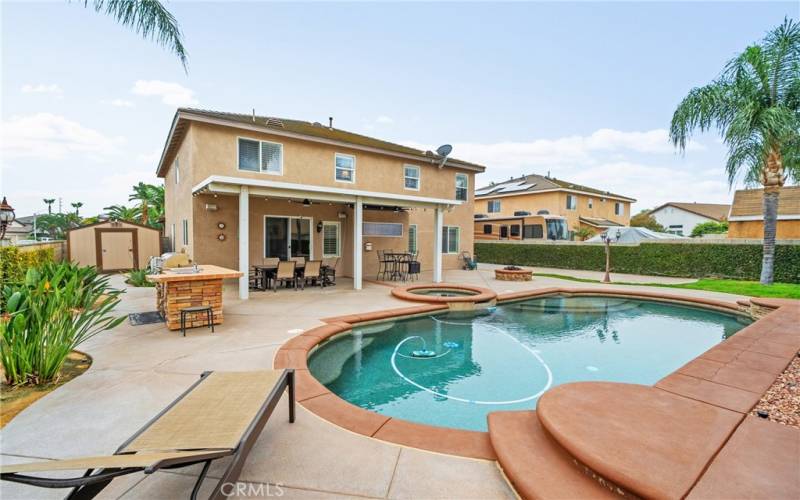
(475, 174, 636, 237)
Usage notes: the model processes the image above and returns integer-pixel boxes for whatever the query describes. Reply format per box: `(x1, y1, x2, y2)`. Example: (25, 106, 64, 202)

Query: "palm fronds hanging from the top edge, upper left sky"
(83, 0, 187, 71)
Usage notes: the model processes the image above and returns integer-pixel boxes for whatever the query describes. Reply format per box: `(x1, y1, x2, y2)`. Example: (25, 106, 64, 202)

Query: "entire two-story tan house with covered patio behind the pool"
(157, 109, 485, 298)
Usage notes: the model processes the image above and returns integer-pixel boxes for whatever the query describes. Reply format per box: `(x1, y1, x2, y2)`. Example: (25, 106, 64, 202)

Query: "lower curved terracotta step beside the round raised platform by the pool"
(488, 411, 619, 499)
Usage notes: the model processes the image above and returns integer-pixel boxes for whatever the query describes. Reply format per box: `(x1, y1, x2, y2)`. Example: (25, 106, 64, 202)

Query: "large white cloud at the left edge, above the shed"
(0, 113, 124, 160)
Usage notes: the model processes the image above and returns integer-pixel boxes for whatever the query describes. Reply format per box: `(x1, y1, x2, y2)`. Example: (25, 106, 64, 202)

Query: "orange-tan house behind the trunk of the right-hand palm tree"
(728, 186, 800, 240)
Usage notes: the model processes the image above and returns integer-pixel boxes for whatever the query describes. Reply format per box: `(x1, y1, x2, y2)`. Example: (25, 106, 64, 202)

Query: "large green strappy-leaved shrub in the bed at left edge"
(0, 262, 124, 385)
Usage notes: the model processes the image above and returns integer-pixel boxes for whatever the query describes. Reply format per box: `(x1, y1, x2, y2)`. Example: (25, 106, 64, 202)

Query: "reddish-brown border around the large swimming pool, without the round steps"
(273, 284, 800, 460)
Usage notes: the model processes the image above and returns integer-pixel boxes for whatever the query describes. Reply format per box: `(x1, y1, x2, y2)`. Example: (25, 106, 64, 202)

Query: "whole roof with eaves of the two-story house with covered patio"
(156, 108, 486, 177)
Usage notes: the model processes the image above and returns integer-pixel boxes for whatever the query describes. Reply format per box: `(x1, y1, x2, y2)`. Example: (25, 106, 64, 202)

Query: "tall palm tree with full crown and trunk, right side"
(670, 19, 800, 285)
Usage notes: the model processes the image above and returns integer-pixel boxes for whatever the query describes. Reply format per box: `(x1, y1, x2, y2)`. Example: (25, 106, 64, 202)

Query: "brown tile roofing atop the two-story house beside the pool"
(158, 108, 486, 174)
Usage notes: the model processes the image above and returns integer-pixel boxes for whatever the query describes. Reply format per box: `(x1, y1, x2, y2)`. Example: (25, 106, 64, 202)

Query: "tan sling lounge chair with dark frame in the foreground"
(0, 370, 295, 500)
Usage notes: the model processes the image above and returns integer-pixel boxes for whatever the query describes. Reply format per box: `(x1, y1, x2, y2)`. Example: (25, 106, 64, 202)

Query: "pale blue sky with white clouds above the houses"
(0, 1, 800, 216)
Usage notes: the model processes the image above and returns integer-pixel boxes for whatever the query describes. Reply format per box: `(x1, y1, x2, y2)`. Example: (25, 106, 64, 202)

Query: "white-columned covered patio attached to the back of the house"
(192, 175, 461, 300)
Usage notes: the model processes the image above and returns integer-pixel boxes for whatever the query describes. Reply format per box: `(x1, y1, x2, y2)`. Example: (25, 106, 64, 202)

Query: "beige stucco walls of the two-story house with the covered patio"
(164, 123, 475, 279)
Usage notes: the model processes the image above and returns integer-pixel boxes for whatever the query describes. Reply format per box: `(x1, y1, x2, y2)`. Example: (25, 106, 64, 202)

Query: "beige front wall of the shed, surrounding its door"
(67, 222, 161, 269)
